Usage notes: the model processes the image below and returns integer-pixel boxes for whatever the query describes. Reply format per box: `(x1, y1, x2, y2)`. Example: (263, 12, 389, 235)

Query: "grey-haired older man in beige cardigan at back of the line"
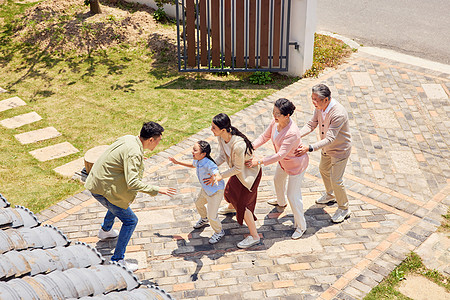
(296, 84, 351, 223)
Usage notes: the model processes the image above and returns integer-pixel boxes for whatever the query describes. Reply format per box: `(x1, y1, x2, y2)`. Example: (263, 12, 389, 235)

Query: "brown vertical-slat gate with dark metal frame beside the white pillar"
(176, 0, 291, 72)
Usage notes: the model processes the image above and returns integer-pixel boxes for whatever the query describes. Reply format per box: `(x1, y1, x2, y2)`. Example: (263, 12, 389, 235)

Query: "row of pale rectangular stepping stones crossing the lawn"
(0, 88, 83, 172)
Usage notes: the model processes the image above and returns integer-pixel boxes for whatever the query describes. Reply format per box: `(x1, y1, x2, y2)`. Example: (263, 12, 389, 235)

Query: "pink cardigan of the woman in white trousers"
(253, 120, 309, 175)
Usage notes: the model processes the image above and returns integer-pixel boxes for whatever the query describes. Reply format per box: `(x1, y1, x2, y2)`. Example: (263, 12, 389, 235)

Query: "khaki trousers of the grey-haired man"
(319, 152, 348, 209)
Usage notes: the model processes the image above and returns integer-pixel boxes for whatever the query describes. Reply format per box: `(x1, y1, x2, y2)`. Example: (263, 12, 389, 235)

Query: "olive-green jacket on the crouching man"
(84, 135, 159, 209)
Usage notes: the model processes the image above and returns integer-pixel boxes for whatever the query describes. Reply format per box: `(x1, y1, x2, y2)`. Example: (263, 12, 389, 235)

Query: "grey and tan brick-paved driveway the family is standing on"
(37, 54, 450, 300)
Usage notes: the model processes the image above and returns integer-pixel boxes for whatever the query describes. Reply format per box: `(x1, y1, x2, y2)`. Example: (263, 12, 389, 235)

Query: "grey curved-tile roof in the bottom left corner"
(0, 194, 172, 300)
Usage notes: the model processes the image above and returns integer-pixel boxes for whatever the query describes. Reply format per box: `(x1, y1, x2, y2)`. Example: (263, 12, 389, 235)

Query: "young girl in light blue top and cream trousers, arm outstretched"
(169, 141, 225, 244)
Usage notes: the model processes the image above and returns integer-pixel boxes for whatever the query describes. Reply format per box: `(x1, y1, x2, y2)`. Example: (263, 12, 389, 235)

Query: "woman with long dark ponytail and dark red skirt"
(205, 113, 261, 248)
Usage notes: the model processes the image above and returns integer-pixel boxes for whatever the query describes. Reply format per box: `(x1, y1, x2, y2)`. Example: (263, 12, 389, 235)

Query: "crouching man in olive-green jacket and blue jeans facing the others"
(85, 122, 176, 271)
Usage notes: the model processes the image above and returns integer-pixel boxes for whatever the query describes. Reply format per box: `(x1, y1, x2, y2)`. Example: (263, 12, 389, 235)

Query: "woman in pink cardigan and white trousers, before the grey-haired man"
(247, 98, 309, 239)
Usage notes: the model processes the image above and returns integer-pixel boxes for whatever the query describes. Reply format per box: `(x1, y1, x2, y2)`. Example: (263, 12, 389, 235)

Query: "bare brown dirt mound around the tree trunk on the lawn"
(12, 0, 176, 54)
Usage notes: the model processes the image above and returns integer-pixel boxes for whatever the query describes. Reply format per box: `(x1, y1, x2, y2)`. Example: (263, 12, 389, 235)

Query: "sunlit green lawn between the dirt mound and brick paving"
(0, 0, 297, 212)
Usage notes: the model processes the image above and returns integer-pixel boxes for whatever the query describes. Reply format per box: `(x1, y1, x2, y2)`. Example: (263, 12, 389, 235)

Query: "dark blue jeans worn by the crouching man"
(92, 193, 138, 261)
